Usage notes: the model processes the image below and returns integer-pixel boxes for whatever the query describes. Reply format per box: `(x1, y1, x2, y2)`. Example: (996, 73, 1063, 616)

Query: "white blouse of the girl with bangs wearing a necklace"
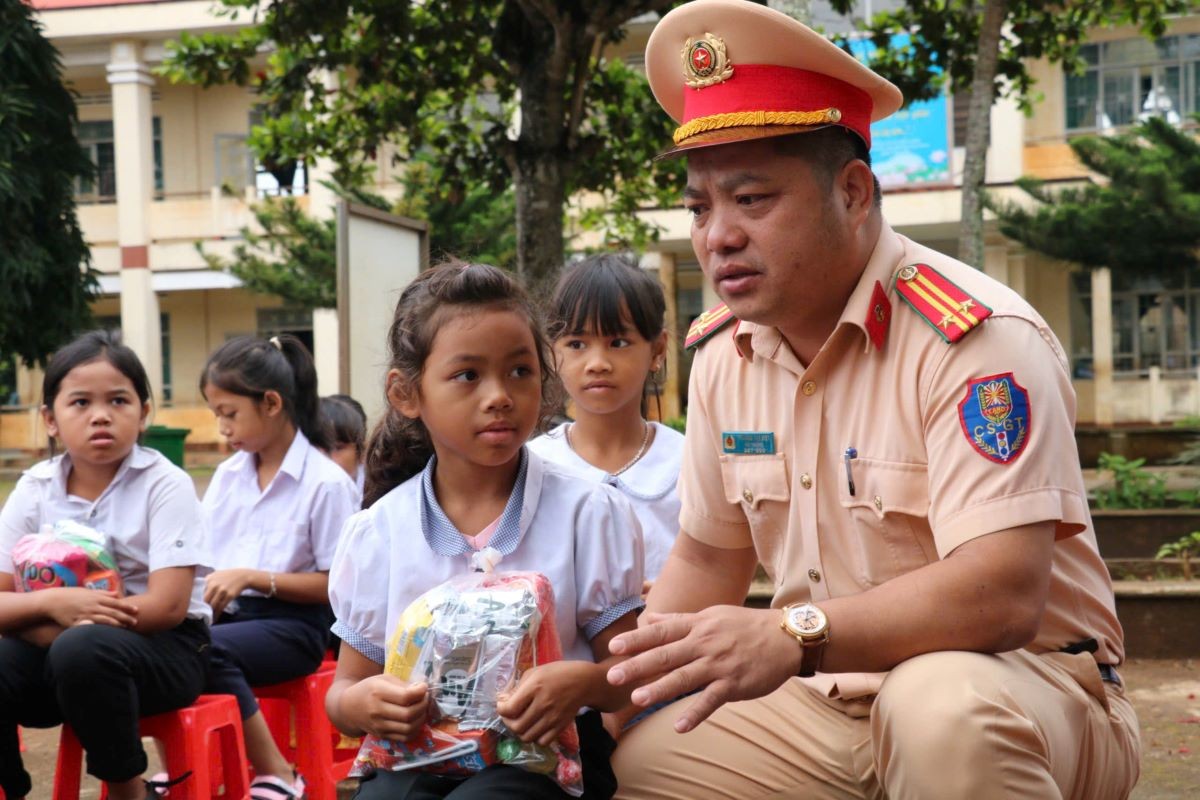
(529, 422, 684, 581)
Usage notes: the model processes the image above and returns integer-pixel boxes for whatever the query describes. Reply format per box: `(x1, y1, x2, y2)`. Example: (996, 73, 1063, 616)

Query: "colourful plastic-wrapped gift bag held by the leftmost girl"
(12, 519, 125, 596)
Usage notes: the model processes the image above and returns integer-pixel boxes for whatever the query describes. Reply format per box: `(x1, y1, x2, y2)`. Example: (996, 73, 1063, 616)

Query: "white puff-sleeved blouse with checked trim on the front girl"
(329, 450, 644, 664)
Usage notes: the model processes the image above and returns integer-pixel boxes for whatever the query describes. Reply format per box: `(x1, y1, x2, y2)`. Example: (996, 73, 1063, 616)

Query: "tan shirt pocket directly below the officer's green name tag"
(720, 453, 792, 568)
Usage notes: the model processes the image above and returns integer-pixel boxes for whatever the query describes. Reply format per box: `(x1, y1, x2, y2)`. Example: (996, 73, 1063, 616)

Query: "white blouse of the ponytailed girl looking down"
(204, 431, 361, 597)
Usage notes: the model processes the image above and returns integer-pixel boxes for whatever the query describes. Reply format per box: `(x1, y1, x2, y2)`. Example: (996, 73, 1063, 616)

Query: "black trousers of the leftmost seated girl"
(0, 620, 209, 798)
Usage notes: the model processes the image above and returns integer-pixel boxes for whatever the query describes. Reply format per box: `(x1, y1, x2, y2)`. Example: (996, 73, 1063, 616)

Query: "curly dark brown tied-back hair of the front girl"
(362, 259, 558, 509)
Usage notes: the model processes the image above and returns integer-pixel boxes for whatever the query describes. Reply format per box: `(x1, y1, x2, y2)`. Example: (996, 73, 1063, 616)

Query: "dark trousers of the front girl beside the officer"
(354, 711, 617, 800)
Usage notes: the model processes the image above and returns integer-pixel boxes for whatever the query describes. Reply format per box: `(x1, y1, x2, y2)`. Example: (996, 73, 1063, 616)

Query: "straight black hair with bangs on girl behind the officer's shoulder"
(547, 253, 667, 342)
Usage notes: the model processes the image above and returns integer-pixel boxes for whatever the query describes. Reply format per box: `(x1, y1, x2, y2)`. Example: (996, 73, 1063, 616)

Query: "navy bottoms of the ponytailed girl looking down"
(204, 597, 332, 720)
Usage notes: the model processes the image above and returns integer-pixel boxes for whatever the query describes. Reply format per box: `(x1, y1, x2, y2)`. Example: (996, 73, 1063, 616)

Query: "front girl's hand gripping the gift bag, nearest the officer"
(496, 661, 596, 747)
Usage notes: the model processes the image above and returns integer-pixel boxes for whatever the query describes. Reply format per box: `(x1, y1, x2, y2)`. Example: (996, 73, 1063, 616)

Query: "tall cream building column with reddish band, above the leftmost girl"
(108, 40, 162, 401)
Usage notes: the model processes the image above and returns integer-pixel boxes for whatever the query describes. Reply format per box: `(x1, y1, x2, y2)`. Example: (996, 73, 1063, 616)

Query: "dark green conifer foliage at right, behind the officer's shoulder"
(989, 118, 1200, 273)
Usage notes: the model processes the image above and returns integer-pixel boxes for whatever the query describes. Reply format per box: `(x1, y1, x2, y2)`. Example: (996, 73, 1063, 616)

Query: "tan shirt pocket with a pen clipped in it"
(838, 458, 937, 587)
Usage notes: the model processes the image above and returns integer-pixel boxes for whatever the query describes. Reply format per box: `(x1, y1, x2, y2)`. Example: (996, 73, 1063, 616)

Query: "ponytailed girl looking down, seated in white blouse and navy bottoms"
(200, 336, 359, 800)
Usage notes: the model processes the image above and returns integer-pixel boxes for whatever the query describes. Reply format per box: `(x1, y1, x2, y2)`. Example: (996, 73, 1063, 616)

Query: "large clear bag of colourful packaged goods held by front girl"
(350, 548, 583, 796)
